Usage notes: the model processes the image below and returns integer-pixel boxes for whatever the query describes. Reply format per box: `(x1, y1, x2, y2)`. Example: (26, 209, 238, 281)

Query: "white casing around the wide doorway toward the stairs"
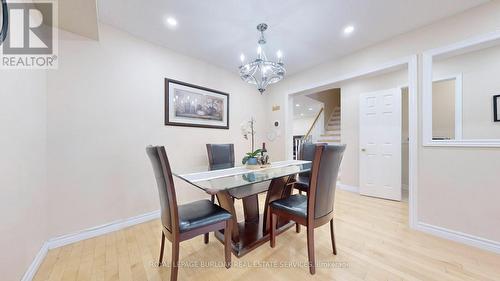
(284, 55, 419, 229)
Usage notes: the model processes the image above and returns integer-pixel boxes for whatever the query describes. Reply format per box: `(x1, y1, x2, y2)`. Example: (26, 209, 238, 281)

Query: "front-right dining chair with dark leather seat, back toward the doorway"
(269, 145, 345, 274)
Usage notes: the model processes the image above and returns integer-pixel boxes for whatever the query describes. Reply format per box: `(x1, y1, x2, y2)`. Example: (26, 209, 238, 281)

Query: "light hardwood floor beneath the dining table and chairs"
(34, 191, 500, 281)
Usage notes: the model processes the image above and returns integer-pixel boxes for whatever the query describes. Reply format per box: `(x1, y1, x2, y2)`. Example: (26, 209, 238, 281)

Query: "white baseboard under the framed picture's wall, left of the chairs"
(47, 210, 160, 249)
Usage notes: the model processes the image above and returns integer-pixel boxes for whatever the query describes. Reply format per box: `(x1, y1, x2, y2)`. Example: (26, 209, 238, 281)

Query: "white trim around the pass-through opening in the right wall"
(422, 30, 500, 147)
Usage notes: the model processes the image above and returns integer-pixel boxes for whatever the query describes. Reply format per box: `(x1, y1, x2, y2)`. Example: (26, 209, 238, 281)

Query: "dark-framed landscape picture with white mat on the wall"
(165, 78, 229, 129)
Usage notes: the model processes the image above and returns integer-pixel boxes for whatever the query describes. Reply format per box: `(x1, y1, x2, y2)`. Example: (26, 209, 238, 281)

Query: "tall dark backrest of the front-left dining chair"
(146, 146, 179, 233)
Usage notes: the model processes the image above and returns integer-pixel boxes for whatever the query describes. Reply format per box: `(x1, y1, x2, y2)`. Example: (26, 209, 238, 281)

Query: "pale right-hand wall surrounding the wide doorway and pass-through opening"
(266, 1, 500, 241)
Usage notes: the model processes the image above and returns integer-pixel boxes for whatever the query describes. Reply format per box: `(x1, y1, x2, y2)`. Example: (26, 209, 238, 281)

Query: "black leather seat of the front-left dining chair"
(179, 200, 231, 232)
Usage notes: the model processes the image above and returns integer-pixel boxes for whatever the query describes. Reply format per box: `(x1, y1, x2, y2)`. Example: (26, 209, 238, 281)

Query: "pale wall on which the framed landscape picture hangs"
(48, 25, 265, 236)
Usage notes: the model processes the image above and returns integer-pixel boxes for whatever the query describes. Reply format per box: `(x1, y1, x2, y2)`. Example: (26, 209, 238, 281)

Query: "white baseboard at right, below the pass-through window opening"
(415, 222, 500, 254)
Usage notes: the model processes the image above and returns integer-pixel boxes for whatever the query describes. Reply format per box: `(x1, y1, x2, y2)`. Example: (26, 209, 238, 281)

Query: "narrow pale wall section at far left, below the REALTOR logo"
(0, 70, 48, 280)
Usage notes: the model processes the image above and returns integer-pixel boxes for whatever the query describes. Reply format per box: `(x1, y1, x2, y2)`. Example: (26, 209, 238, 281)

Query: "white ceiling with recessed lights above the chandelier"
(98, 0, 488, 74)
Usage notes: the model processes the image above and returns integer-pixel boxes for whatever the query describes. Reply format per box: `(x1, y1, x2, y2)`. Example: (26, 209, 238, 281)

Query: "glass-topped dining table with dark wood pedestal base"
(173, 160, 312, 257)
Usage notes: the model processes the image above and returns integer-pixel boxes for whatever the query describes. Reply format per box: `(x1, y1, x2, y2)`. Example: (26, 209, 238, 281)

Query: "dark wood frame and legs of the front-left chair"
(153, 147, 233, 281)
